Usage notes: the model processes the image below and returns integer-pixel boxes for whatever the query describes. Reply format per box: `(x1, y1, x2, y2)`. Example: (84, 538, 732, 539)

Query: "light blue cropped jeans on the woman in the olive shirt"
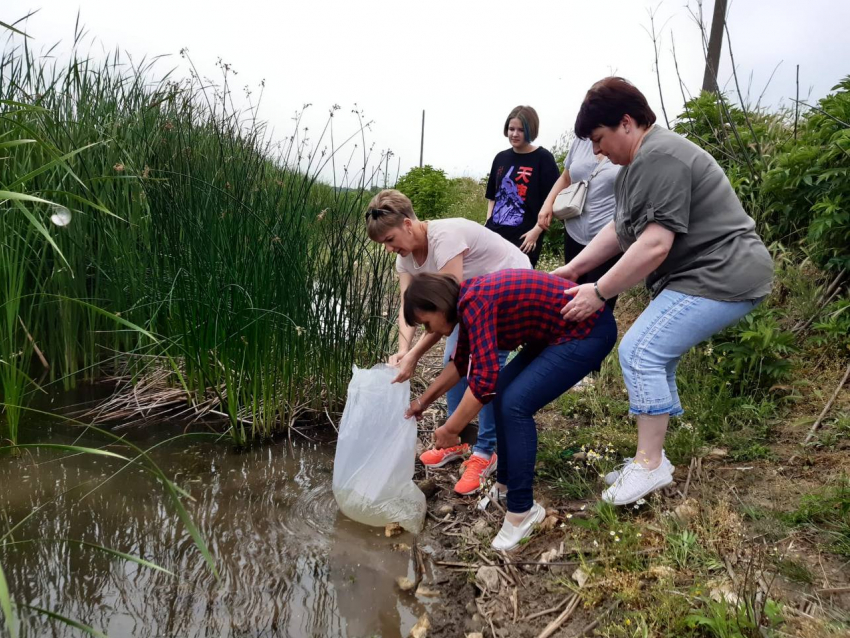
(618, 290, 764, 416)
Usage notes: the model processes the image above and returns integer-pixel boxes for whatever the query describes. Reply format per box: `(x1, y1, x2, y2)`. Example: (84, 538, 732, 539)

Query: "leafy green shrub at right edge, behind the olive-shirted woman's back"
(674, 77, 850, 271)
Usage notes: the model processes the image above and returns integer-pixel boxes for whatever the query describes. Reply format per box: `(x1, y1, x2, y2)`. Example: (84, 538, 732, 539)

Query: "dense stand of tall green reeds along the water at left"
(0, 32, 395, 443)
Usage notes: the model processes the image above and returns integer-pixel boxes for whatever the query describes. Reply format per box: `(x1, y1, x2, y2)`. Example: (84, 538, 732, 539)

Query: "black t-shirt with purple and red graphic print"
(484, 147, 560, 265)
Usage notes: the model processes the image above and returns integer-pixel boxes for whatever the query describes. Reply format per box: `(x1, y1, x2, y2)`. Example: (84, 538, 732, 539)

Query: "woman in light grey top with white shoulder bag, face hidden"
(535, 138, 620, 310)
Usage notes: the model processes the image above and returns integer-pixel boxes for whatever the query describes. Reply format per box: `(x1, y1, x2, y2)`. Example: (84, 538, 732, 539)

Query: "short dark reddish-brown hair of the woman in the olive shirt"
(575, 76, 655, 139)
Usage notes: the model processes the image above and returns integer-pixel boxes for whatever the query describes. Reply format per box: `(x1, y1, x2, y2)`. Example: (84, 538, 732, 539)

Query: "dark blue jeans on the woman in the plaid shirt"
(493, 307, 617, 513)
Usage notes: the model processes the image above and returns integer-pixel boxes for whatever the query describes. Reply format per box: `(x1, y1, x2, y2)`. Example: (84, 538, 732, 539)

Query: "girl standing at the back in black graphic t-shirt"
(484, 106, 560, 267)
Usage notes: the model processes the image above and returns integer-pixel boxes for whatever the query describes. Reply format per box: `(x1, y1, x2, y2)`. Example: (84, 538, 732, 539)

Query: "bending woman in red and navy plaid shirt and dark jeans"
(404, 270, 617, 551)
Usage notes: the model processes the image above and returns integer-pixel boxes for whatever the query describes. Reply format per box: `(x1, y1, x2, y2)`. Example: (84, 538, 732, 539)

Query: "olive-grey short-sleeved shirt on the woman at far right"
(614, 126, 773, 301)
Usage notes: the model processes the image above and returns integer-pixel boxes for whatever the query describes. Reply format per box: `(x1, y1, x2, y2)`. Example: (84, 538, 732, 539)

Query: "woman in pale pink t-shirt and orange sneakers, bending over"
(366, 190, 531, 494)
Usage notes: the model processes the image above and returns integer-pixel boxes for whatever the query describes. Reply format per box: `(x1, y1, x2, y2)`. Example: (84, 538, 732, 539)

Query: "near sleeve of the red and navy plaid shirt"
(454, 298, 499, 403)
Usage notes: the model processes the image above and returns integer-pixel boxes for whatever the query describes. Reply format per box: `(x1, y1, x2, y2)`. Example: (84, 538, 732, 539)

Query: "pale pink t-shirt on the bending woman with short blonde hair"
(395, 218, 531, 280)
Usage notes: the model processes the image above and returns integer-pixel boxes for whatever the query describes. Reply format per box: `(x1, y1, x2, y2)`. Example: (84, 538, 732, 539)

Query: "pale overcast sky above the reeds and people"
(0, 0, 850, 181)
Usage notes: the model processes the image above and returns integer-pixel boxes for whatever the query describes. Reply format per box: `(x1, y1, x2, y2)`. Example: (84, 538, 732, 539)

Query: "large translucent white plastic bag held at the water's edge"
(333, 364, 426, 534)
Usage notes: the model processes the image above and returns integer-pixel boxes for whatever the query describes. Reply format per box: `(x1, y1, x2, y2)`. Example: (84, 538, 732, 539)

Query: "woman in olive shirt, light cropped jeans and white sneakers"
(554, 77, 773, 505)
